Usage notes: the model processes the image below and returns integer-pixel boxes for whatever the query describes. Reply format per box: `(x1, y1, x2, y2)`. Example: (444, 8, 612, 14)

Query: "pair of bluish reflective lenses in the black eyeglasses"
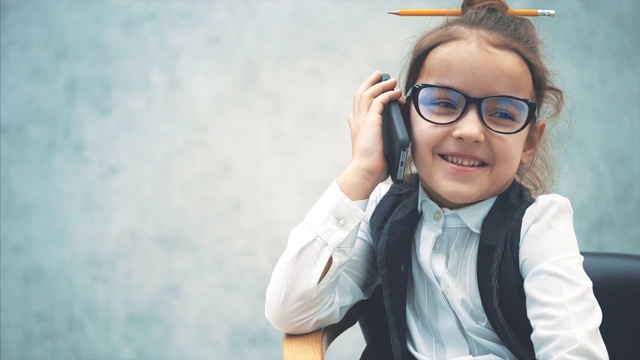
(418, 87, 529, 133)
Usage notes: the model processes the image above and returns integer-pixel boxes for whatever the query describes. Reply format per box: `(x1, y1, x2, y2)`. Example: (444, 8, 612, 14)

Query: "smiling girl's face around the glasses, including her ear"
(410, 39, 546, 209)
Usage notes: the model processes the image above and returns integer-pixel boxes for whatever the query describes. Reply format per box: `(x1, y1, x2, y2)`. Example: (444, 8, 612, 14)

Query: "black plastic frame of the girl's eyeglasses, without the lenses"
(406, 84, 537, 135)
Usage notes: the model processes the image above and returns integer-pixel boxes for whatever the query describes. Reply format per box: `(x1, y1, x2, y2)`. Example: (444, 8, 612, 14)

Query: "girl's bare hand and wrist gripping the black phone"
(338, 71, 404, 200)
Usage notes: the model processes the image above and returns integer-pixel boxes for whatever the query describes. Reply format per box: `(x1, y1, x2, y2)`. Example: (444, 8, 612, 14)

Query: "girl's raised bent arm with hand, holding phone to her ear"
(265, 71, 404, 333)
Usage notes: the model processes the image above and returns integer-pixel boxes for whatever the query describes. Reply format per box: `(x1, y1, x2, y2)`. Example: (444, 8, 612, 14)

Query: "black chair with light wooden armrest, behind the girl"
(282, 252, 640, 360)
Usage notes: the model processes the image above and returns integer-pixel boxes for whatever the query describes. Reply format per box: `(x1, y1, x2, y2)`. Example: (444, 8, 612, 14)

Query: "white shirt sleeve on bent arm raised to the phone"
(265, 181, 384, 334)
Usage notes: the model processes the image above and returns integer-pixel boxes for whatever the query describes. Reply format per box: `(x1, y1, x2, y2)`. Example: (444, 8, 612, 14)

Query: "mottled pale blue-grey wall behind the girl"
(0, 1, 640, 359)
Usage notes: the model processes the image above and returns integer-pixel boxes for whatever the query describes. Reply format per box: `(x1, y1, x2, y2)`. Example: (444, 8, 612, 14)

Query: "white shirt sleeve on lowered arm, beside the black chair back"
(520, 195, 608, 359)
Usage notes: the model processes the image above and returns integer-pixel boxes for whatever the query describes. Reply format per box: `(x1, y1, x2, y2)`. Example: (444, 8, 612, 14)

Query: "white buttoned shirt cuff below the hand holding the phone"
(305, 181, 368, 248)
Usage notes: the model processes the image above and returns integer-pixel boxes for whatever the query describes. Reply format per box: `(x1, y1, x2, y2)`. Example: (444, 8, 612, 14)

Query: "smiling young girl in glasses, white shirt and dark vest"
(266, 0, 607, 359)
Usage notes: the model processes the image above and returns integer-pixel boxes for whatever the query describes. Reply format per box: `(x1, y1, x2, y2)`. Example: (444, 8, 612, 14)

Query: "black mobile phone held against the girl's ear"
(380, 74, 410, 183)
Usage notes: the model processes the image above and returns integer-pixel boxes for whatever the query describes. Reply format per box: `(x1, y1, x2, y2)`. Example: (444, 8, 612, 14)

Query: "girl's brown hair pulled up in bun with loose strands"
(405, 0, 564, 195)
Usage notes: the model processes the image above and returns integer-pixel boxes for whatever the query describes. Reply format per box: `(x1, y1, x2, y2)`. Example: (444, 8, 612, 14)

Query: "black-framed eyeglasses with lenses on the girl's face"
(407, 84, 536, 134)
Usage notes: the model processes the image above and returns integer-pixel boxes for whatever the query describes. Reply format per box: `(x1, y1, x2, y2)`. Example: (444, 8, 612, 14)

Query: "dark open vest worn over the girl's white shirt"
(360, 179, 535, 360)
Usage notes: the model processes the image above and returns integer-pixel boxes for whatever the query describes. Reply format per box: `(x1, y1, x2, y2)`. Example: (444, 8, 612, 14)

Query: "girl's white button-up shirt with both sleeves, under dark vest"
(265, 182, 608, 359)
